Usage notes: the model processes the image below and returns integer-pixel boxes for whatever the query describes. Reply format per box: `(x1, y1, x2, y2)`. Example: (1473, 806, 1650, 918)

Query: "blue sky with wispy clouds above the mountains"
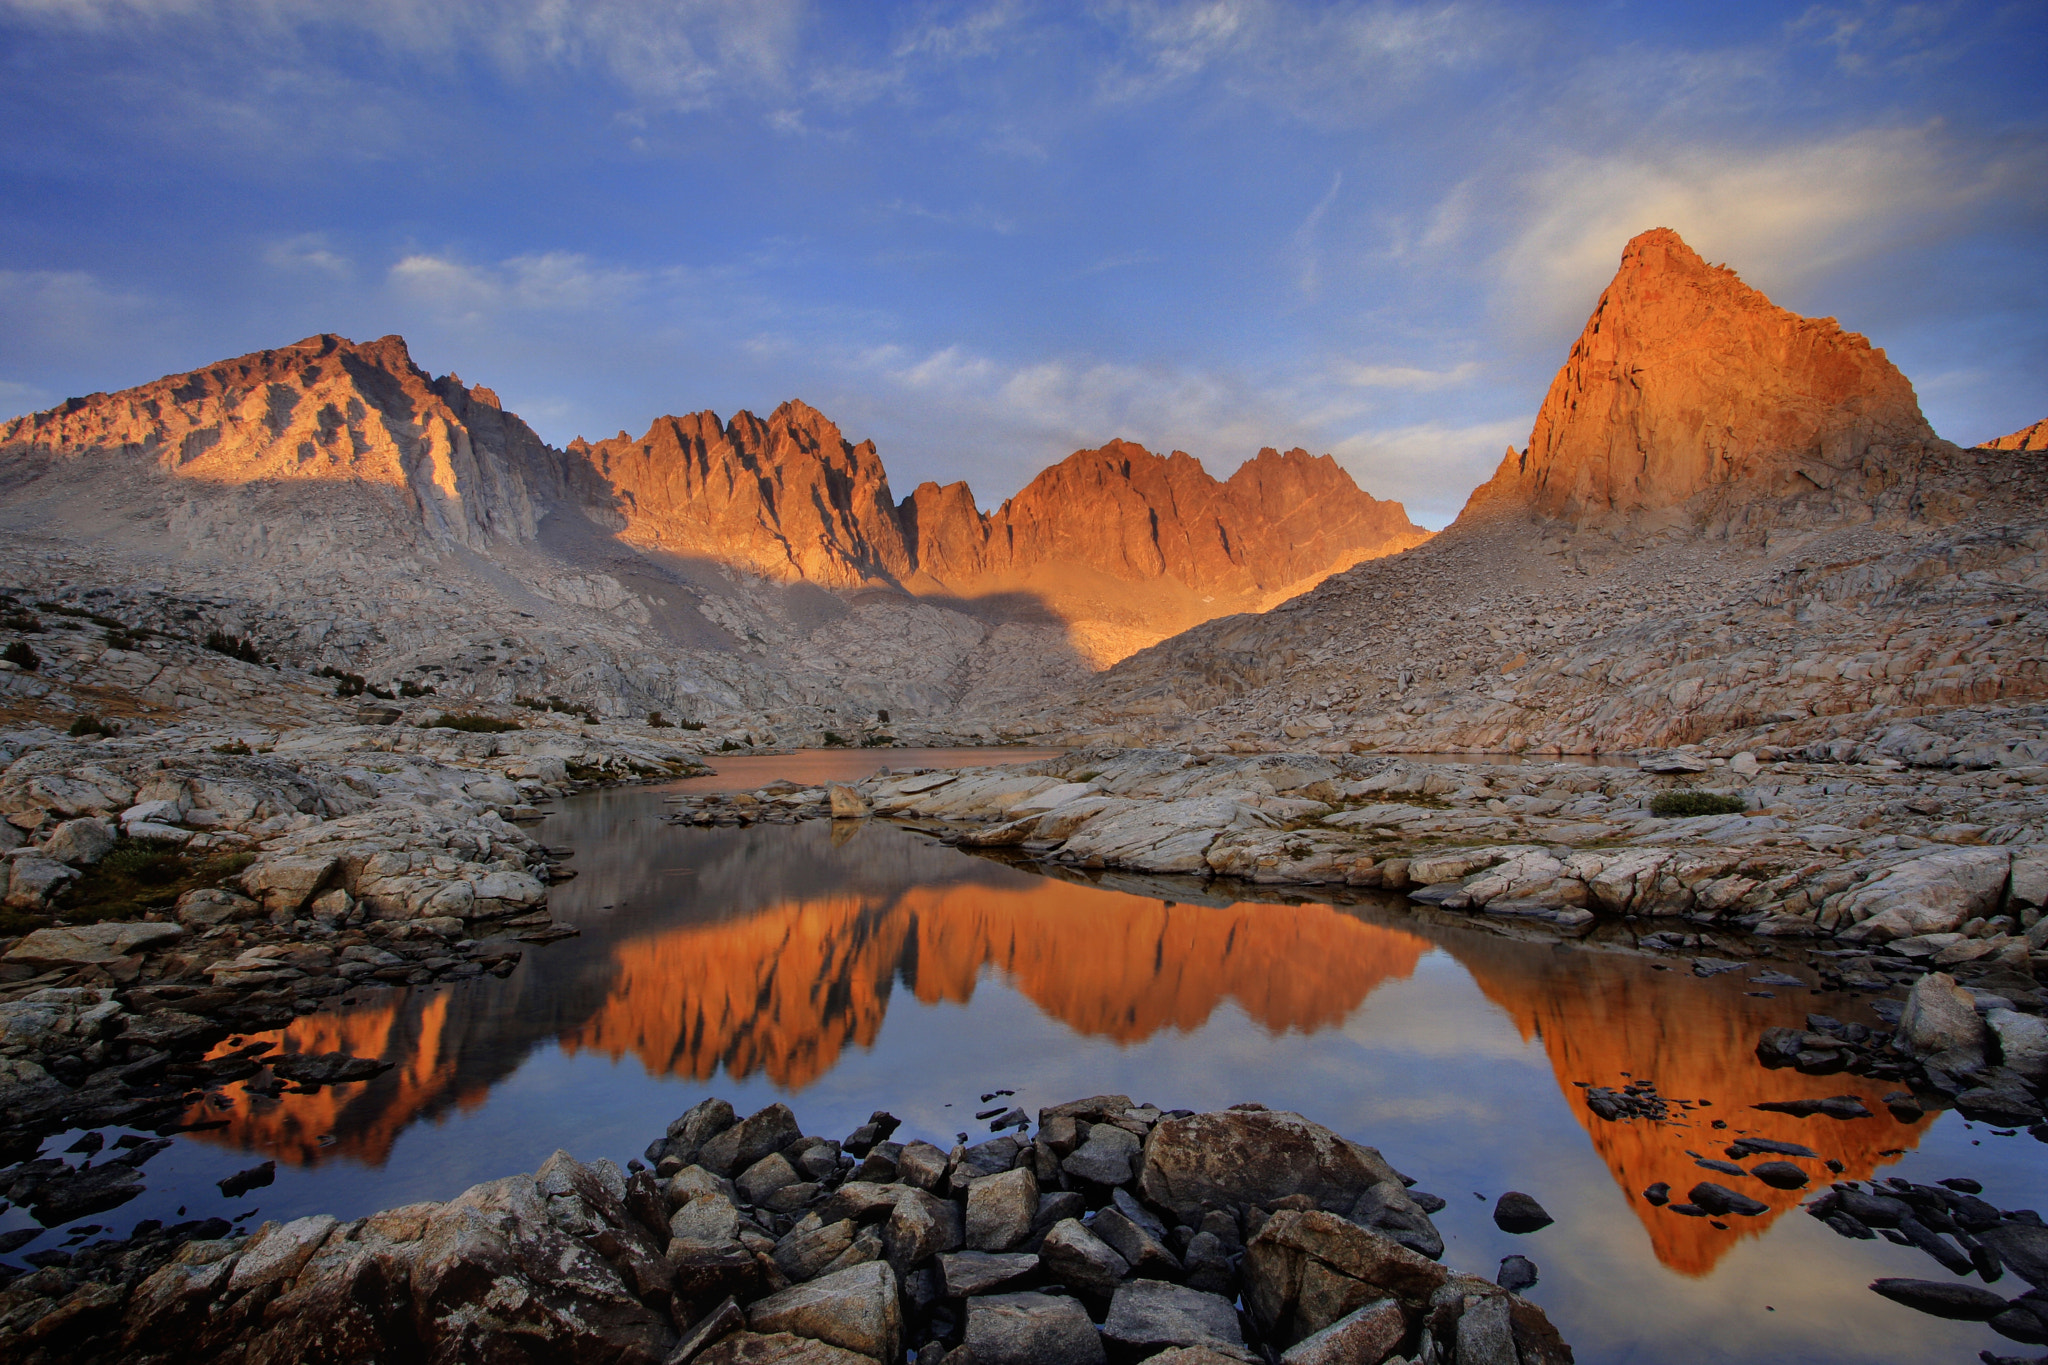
(0, 0, 2048, 526)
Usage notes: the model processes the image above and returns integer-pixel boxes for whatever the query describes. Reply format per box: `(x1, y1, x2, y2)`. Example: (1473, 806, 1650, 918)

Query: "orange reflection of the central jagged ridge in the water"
(563, 882, 1427, 1089)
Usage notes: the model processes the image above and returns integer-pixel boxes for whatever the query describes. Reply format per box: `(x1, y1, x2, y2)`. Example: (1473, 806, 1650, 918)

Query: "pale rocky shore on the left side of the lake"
(0, 722, 702, 1170)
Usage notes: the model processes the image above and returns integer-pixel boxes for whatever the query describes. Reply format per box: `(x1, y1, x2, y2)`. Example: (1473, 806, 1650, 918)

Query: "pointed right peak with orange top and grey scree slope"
(1044, 229, 2048, 753)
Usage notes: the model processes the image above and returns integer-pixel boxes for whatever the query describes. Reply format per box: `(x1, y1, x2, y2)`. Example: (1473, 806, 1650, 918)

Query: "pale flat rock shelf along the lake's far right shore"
(672, 747, 2048, 957)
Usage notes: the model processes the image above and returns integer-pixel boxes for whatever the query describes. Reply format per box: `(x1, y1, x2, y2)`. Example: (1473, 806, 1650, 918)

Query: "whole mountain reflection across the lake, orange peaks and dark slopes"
(203, 792, 1931, 1275)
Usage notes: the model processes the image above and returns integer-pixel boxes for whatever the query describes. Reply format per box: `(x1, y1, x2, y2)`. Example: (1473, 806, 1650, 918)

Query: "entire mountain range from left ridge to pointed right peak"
(0, 229, 2048, 769)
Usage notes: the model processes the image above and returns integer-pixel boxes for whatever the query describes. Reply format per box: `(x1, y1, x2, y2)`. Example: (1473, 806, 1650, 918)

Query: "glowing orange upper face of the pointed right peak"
(1473, 227, 1946, 522)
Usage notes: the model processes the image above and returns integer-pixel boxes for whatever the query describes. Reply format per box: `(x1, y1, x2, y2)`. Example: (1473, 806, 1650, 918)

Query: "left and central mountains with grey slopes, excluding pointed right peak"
(0, 336, 1427, 743)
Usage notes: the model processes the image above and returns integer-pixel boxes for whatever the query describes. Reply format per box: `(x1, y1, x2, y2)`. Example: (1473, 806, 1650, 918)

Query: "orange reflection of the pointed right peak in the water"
(1452, 945, 1933, 1275)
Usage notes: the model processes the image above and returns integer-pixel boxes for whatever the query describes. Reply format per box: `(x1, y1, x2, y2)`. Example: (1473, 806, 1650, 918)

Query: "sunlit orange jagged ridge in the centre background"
(567, 421, 1430, 663)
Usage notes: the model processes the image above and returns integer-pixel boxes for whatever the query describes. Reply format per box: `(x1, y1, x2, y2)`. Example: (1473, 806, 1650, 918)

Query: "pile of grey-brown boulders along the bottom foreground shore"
(0, 1095, 1573, 1365)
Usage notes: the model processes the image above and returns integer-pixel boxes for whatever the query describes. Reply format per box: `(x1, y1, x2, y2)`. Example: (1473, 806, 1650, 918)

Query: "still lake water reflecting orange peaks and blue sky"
(14, 751, 2048, 1365)
